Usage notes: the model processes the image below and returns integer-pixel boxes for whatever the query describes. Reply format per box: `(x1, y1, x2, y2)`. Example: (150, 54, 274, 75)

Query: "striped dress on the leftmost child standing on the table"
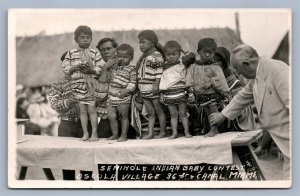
(61, 48, 104, 104)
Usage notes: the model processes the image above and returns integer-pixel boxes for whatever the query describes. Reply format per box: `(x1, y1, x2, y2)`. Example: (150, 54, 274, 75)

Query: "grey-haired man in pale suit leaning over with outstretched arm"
(210, 45, 290, 179)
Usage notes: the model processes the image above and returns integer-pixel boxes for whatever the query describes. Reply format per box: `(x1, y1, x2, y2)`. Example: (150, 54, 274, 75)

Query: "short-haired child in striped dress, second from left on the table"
(107, 44, 136, 142)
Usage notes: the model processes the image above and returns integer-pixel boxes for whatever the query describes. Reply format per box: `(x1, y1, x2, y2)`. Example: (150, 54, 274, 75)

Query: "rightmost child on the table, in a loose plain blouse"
(187, 38, 229, 137)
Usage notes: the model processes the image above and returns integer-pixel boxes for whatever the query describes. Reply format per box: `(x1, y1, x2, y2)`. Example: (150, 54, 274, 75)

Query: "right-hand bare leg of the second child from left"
(117, 104, 129, 142)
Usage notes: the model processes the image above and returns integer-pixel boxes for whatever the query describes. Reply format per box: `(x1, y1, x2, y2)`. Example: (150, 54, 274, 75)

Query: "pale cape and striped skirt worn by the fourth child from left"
(159, 62, 187, 105)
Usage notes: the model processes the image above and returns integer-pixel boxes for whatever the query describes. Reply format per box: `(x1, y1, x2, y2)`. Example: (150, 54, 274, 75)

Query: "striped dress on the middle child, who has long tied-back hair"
(138, 51, 164, 98)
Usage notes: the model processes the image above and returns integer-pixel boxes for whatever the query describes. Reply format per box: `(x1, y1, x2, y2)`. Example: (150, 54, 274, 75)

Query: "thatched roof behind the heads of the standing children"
(16, 28, 240, 86)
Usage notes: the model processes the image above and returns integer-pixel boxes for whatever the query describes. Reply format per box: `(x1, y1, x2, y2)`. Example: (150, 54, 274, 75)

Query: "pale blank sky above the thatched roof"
(9, 9, 291, 57)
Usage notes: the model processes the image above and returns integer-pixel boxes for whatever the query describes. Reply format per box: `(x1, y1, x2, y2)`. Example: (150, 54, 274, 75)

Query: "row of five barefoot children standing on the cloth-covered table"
(62, 26, 230, 141)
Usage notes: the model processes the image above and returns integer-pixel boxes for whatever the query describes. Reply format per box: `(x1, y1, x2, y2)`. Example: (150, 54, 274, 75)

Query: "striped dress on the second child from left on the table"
(107, 65, 136, 106)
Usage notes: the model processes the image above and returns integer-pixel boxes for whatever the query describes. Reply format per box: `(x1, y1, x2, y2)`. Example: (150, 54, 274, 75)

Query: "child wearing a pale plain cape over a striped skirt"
(159, 41, 192, 139)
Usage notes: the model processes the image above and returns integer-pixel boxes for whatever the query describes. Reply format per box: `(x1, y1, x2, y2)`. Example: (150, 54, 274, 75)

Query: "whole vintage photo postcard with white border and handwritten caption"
(8, 8, 293, 188)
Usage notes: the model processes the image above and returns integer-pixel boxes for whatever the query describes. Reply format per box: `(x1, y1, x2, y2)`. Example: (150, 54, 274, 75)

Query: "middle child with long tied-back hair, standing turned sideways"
(137, 30, 166, 139)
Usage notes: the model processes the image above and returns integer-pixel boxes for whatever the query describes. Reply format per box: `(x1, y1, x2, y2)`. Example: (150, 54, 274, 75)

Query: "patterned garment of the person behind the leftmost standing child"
(48, 79, 78, 121)
